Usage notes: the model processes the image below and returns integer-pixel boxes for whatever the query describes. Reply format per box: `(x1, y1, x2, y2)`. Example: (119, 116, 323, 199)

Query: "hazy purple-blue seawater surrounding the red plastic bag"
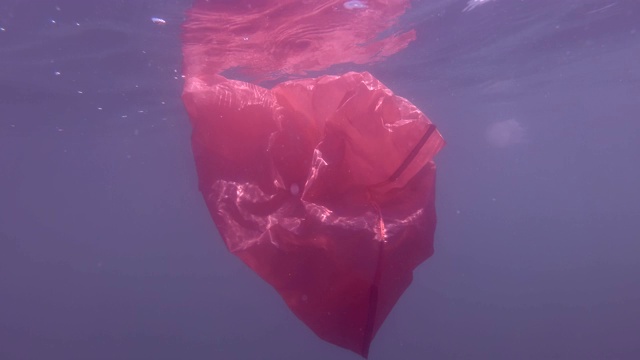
(0, 0, 640, 360)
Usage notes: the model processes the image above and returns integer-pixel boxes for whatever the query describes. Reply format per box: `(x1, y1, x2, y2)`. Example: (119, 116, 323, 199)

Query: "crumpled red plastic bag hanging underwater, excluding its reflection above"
(183, 72, 444, 357)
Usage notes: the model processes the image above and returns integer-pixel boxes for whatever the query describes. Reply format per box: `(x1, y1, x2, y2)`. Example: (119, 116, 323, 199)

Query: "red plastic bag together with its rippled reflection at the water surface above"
(183, 0, 444, 357)
